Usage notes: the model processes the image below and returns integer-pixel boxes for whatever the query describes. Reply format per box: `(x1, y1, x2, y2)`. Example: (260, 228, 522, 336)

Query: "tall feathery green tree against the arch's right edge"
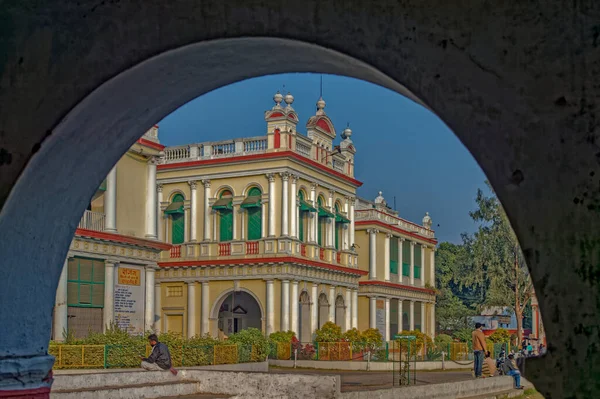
(455, 182, 533, 342)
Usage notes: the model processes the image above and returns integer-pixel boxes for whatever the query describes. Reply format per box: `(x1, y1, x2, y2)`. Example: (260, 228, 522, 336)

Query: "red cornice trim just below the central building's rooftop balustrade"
(157, 151, 363, 187)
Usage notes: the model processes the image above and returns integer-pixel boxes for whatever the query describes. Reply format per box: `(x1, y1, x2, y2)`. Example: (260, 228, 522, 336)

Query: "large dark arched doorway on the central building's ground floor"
(217, 291, 262, 335)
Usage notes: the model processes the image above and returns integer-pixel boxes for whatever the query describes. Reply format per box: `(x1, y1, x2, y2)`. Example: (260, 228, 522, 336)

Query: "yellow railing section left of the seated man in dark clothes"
(48, 345, 105, 368)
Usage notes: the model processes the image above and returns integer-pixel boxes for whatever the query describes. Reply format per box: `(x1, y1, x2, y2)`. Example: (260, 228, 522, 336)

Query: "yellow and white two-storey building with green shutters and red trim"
(52, 93, 436, 341)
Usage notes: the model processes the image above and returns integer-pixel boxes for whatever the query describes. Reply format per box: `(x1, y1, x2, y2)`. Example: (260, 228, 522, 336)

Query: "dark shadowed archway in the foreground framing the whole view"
(0, 0, 600, 397)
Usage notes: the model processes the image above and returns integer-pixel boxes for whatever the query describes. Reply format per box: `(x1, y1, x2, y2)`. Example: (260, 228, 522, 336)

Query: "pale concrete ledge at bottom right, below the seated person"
(340, 377, 523, 399)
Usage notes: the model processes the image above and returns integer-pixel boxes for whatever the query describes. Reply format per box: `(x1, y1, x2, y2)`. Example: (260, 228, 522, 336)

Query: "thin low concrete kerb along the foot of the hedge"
(269, 360, 473, 371)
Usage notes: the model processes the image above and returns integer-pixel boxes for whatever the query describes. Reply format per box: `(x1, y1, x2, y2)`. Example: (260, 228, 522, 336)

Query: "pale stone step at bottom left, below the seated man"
(50, 381, 199, 399)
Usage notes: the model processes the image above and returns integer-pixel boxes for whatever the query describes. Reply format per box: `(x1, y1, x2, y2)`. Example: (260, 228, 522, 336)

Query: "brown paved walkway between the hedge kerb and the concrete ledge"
(269, 367, 473, 392)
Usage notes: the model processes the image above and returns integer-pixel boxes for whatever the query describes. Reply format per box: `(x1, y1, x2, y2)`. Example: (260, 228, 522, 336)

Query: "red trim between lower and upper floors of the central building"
(158, 256, 369, 276)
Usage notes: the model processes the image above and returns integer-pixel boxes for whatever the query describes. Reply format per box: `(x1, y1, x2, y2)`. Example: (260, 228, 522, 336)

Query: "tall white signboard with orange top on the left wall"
(114, 264, 145, 334)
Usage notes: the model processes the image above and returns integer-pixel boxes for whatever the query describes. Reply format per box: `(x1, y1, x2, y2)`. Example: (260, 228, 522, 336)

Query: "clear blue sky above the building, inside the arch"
(159, 74, 485, 243)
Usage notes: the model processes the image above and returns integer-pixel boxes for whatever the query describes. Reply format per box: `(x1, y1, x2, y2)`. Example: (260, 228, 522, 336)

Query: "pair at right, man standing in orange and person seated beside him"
(473, 323, 523, 389)
